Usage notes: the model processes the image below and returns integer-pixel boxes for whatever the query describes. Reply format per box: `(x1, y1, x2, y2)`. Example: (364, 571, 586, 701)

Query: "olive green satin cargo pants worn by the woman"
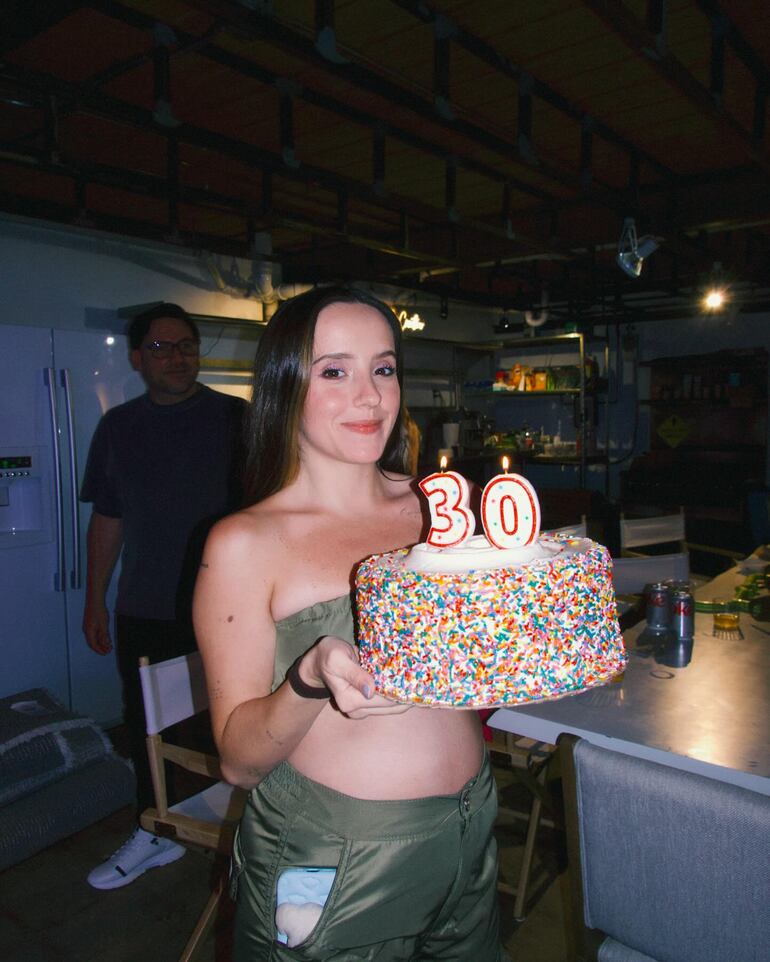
(233, 753, 507, 962)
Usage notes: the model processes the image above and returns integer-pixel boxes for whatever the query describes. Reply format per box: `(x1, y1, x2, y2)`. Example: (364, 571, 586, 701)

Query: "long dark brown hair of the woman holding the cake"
(244, 286, 408, 505)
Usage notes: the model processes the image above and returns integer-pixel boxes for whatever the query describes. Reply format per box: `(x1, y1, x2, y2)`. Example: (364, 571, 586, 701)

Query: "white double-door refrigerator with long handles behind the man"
(0, 325, 143, 725)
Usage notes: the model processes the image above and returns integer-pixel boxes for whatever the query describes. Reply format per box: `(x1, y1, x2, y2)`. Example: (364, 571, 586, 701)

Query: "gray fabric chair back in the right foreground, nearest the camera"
(559, 735, 770, 962)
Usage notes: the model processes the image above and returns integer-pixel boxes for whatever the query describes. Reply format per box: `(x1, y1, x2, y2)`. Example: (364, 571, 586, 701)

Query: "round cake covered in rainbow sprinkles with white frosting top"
(356, 536, 626, 708)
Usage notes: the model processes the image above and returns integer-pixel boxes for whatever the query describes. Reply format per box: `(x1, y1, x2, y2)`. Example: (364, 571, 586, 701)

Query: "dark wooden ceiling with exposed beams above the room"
(0, 0, 770, 312)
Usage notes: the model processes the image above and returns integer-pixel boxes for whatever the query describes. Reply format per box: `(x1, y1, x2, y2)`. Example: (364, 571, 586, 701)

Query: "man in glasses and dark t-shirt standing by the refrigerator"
(80, 304, 245, 889)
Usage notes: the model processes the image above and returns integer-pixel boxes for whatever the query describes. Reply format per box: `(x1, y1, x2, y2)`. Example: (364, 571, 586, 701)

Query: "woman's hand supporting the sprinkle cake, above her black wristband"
(301, 635, 411, 720)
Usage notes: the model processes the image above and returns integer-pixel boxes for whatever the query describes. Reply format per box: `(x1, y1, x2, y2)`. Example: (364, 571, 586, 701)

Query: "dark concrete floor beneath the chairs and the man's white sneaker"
(0, 776, 566, 962)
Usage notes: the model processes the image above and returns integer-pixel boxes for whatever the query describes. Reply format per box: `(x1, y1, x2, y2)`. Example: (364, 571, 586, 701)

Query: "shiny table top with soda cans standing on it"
(488, 600, 770, 795)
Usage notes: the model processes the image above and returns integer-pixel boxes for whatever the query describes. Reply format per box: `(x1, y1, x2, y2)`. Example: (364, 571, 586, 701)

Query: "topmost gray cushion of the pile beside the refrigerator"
(0, 688, 112, 806)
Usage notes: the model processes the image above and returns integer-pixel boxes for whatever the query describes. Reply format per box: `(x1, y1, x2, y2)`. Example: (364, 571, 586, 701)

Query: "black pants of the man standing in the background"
(115, 614, 196, 815)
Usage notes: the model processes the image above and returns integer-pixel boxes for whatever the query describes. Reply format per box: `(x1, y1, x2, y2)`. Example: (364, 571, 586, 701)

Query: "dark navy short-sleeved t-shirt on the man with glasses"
(80, 385, 246, 621)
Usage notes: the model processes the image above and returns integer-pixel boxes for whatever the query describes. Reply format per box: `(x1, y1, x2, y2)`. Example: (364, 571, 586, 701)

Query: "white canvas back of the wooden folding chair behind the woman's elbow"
(139, 651, 209, 735)
